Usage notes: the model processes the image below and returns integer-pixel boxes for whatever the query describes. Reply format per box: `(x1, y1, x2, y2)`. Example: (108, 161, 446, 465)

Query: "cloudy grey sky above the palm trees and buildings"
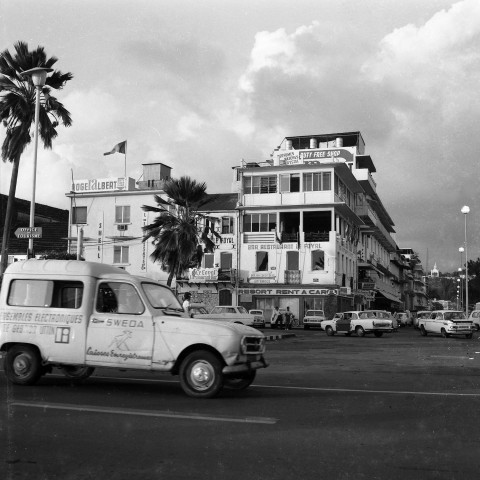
(0, 0, 480, 272)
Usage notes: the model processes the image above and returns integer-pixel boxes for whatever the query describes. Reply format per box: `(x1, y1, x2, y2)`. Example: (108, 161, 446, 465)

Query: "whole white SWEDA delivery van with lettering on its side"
(0, 259, 267, 398)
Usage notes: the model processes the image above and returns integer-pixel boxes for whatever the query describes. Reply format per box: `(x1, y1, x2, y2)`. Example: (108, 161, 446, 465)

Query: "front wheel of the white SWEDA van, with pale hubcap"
(180, 350, 224, 398)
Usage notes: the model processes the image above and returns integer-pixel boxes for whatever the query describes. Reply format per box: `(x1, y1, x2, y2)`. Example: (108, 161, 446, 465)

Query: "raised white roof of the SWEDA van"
(5, 258, 131, 278)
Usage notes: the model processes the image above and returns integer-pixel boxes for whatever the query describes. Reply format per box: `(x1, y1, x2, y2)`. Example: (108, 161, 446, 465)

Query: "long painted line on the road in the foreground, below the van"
(9, 402, 278, 425)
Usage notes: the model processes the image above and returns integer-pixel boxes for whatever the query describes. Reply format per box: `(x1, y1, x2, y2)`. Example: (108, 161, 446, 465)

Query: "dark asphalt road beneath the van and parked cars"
(0, 328, 480, 480)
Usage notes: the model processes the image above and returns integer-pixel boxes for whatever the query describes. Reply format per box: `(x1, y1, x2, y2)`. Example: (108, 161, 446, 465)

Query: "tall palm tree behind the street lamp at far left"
(0, 42, 73, 274)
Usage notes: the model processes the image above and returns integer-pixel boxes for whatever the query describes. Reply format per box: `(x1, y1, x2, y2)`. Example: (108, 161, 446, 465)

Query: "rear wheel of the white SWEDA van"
(4, 345, 43, 385)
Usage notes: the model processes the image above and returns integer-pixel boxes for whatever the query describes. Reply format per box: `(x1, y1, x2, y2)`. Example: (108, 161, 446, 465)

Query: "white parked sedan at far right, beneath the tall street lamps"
(418, 310, 475, 338)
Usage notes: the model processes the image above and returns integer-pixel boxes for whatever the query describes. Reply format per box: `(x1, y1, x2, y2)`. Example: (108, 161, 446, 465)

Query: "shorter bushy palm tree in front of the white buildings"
(142, 177, 213, 286)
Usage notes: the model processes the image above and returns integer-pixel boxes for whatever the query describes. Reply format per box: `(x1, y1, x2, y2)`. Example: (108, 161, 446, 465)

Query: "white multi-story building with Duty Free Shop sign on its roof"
(235, 132, 400, 317)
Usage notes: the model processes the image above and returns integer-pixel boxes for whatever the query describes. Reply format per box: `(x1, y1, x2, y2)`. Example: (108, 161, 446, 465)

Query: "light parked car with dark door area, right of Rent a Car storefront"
(322, 310, 393, 337)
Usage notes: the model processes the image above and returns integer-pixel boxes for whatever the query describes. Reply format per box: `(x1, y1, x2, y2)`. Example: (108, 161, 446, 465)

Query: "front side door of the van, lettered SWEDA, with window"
(86, 280, 155, 368)
